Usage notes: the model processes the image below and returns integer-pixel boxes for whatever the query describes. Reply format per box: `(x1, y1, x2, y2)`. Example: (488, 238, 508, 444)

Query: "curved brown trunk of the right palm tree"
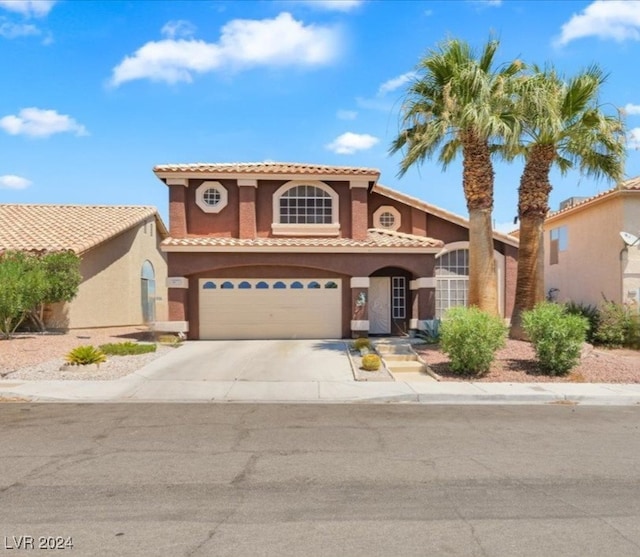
(509, 145, 556, 339)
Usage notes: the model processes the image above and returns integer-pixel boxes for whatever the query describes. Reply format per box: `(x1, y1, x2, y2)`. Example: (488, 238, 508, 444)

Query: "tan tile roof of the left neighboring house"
(0, 204, 168, 254)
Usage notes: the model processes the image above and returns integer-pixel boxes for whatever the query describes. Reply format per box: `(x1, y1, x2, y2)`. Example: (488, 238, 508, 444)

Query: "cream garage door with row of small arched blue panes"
(199, 278, 342, 339)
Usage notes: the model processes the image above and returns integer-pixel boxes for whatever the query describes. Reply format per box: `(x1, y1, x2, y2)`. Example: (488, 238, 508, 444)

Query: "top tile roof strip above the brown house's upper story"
(153, 162, 380, 179)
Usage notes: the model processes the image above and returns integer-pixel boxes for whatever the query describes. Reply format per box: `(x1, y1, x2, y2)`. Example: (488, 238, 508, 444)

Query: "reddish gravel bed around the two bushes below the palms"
(414, 339, 640, 383)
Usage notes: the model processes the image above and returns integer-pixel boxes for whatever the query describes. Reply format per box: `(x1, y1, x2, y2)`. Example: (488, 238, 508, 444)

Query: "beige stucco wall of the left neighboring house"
(47, 218, 168, 329)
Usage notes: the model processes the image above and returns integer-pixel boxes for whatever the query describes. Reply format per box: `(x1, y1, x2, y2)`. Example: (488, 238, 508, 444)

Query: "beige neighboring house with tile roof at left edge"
(0, 204, 168, 329)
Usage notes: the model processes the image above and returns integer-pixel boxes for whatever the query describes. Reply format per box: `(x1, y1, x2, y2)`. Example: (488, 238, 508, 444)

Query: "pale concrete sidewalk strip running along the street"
(0, 373, 640, 406)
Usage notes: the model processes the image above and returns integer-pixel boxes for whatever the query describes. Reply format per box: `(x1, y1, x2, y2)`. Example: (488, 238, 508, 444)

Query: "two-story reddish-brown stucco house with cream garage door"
(154, 163, 517, 339)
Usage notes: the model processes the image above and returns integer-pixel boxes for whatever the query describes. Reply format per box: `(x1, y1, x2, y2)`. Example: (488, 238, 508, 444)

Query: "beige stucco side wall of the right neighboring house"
(544, 196, 628, 305)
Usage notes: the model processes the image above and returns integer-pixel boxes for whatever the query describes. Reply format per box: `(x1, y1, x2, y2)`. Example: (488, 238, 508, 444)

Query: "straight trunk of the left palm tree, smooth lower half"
(461, 130, 498, 315)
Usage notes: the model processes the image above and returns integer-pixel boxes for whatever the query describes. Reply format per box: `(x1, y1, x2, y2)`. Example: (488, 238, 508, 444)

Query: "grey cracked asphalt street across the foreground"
(0, 403, 640, 557)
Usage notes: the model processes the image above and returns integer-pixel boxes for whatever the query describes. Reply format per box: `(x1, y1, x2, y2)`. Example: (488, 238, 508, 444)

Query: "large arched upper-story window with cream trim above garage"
(272, 181, 340, 236)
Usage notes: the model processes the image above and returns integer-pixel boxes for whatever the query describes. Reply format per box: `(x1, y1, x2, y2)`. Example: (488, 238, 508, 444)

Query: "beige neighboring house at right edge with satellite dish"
(544, 177, 640, 307)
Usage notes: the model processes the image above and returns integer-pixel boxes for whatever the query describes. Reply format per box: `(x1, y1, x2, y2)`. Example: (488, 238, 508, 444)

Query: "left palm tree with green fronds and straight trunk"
(390, 39, 523, 314)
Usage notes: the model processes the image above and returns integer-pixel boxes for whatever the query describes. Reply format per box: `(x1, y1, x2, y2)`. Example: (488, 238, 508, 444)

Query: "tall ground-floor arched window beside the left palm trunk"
(435, 249, 469, 319)
